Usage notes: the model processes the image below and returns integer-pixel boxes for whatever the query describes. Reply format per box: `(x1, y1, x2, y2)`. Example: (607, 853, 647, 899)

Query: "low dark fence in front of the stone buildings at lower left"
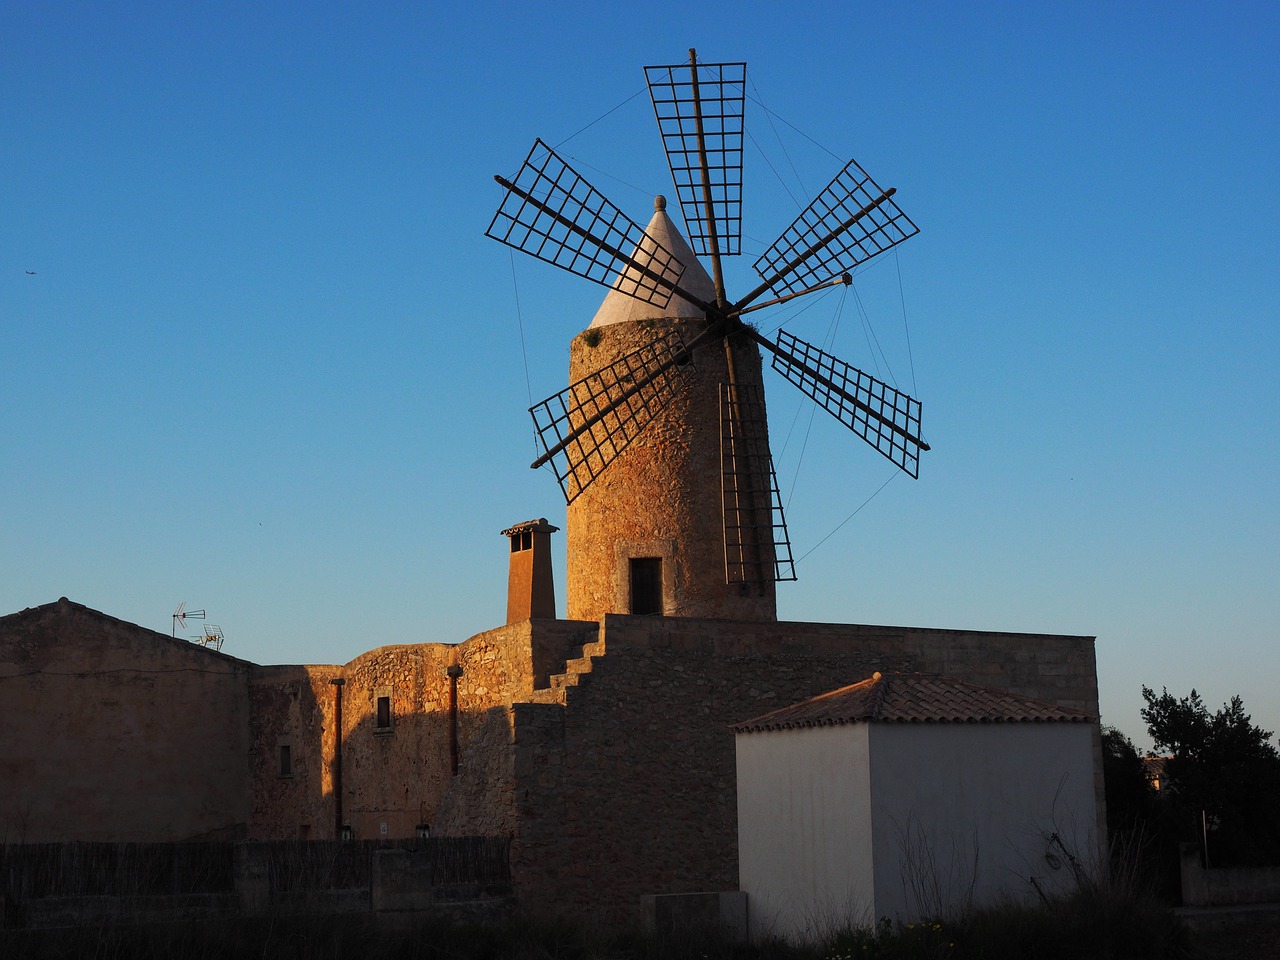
(0, 837, 513, 928)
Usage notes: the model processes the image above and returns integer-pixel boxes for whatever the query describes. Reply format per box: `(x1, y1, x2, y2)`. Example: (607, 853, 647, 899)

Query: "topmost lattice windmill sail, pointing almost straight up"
(644, 56, 746, 256)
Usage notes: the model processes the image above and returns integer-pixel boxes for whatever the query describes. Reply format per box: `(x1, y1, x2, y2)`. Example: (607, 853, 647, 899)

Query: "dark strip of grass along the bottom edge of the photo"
(0, 892, 1198, 960)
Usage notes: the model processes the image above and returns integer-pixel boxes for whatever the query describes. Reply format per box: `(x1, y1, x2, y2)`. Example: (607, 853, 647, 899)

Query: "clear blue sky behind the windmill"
(0, 0, 1280, 741)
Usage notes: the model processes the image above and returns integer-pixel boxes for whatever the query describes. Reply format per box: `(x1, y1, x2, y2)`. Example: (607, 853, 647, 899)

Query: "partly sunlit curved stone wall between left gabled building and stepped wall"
(250, 621, 598, 840)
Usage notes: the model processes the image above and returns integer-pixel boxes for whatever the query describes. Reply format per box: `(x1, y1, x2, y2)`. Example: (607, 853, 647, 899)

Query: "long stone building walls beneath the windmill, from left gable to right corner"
(0, 600, 1105, 920)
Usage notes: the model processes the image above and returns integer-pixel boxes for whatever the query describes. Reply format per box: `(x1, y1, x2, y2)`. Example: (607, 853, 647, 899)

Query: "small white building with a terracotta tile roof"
(733, 673, 1097, 940)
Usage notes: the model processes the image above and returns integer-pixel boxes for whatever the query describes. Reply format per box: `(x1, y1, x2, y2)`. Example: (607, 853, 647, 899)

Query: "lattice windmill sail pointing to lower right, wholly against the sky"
(760, 330, 929, 477)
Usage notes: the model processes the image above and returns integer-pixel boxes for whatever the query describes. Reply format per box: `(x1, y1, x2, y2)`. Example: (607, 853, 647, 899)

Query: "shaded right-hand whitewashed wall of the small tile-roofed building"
(859, 723, 1097, 919)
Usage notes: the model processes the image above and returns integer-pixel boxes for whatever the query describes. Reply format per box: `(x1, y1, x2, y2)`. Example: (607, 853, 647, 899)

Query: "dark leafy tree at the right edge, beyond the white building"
(1140, 686, 1280, 865)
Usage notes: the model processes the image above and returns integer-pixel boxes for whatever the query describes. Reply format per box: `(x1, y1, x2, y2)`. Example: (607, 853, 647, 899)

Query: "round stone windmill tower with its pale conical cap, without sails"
(566, 197, 768, 620)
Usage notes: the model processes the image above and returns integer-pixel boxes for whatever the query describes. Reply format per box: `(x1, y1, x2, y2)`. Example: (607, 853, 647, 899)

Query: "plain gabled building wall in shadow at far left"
(0, 598, 252, 844)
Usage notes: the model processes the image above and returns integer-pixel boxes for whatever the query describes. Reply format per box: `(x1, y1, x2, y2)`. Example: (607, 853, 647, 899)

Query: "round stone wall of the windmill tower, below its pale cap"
(564, 317, 777, 621)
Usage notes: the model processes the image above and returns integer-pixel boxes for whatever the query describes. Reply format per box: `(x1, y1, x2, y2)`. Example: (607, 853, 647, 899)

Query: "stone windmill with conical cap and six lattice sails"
(485, 50, 928, 620)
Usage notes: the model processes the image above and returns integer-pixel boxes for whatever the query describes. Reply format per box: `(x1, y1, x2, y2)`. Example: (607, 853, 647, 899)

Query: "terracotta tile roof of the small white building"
(733, 673, 1092, 733)
